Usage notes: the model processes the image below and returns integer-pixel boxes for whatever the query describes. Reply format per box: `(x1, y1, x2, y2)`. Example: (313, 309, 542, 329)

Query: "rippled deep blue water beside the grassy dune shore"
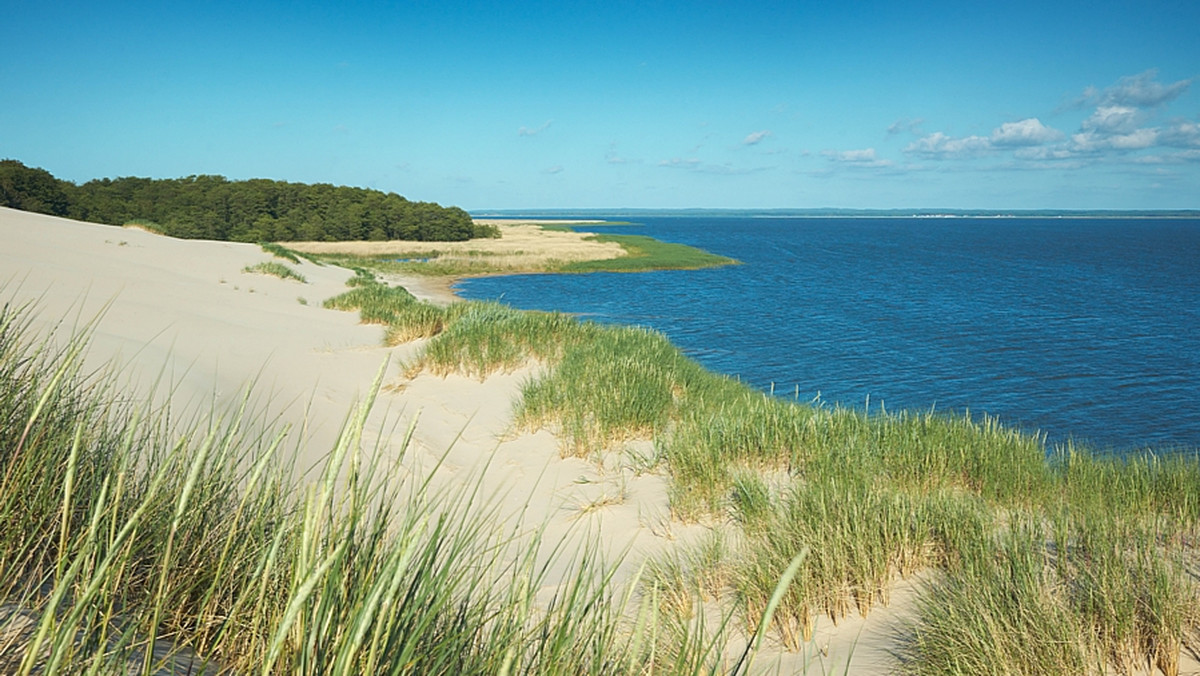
(458, 217, 1200, 451)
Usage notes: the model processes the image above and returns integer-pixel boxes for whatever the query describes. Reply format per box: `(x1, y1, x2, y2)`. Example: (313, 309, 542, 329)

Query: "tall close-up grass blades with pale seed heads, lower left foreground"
(0, 305, 743, 675)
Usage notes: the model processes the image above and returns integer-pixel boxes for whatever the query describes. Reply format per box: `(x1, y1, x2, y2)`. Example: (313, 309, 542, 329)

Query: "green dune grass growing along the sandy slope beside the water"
(321, 268, 1200, 674)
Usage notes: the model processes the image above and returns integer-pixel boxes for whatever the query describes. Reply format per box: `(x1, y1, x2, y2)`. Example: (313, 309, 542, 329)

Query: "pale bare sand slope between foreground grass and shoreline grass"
(0, 208, 695, 643)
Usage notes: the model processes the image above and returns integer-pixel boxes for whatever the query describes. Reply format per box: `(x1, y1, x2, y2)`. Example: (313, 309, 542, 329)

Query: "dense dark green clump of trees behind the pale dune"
(0, 160, 497, 241)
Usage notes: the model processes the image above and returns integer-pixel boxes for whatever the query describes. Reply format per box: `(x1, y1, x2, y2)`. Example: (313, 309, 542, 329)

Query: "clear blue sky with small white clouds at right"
(0, 0, 1200, 210)
